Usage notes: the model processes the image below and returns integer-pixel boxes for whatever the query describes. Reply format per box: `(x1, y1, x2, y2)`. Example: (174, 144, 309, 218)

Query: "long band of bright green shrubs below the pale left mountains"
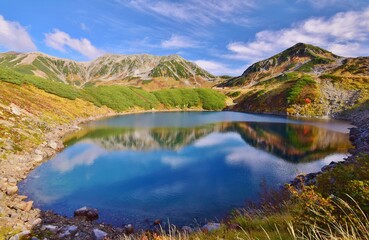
(0, 68, 225, 112)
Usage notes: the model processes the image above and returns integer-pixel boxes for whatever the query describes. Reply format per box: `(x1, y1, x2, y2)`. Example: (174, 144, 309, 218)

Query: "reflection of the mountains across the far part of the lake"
(66, 122, 351, 163)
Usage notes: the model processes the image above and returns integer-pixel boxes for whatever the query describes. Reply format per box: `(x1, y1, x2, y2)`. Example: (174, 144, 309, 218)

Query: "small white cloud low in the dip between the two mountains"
(193, 60, 246, 76)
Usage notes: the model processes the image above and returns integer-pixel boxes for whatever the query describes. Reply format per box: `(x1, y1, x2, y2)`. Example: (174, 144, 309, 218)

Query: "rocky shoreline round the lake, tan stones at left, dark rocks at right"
(0, 111, 369, 240)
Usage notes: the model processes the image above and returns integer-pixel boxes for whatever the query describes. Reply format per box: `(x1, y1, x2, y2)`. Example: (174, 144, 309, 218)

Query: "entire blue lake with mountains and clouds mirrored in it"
(19, 112, 350, 228)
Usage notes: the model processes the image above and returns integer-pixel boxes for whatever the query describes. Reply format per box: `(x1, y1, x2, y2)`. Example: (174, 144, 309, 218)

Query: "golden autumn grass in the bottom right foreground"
(117, 195, 369, 240)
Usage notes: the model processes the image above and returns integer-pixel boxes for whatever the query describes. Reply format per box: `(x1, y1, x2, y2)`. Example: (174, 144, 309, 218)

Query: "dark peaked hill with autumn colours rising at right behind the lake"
(217, 43, 369, 117)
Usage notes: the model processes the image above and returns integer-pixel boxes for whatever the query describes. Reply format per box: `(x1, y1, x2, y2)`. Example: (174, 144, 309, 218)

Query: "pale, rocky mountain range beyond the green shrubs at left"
(0, 52, 216, 89)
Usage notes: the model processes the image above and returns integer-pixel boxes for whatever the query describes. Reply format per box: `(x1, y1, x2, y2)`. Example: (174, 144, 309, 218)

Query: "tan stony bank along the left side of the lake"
(0, 114, 121, 239)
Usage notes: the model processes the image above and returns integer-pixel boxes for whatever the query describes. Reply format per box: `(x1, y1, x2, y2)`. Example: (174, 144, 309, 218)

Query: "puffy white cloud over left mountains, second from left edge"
(45, 29, 104, 59)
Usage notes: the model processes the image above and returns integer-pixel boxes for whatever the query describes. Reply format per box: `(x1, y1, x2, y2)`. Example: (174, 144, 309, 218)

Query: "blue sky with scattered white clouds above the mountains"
(0, 0, 369, 76)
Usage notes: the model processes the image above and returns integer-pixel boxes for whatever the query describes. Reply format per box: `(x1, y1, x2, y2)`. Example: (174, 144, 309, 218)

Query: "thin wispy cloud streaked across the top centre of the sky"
(116, 0, 255, 25)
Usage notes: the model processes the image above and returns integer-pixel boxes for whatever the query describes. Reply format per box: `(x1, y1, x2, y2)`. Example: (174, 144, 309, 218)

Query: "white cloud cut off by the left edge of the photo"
(0, 15, 37, 51)
